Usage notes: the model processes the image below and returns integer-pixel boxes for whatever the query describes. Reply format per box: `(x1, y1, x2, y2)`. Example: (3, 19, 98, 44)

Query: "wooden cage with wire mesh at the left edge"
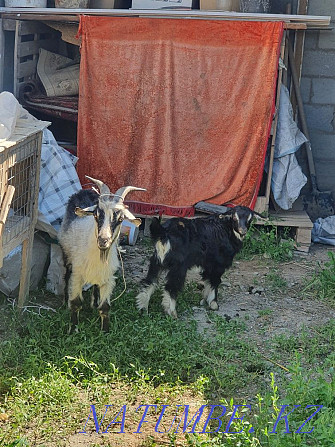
(0, 128, 42, 307)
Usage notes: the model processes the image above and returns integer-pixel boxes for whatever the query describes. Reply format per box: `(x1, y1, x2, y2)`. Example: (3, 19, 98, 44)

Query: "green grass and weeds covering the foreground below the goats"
(0, 243, 335, 447)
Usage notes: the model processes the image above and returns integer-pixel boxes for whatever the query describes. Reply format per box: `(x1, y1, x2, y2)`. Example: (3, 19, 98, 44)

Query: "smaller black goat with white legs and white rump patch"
(136, 206, 254, 318)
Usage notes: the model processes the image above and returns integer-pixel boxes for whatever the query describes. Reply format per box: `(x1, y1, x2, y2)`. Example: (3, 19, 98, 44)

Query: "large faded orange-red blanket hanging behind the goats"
(78, 16, 283, 214)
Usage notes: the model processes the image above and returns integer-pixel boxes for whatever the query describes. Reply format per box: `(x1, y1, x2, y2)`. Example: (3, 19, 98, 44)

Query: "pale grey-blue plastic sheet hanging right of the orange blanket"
(271, 85, 307, 210)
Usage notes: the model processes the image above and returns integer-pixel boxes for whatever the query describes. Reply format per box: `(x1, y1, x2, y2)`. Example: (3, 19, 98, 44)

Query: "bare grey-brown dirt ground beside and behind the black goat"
(123, 241, 335, 348)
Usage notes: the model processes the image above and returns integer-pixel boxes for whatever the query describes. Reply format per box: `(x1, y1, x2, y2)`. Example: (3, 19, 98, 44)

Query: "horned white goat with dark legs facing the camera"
(58, 176, 145, 332)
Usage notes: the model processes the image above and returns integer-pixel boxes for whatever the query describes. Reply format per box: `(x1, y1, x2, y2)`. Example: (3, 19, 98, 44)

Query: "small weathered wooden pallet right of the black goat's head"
(257, 210, 313, 253)
